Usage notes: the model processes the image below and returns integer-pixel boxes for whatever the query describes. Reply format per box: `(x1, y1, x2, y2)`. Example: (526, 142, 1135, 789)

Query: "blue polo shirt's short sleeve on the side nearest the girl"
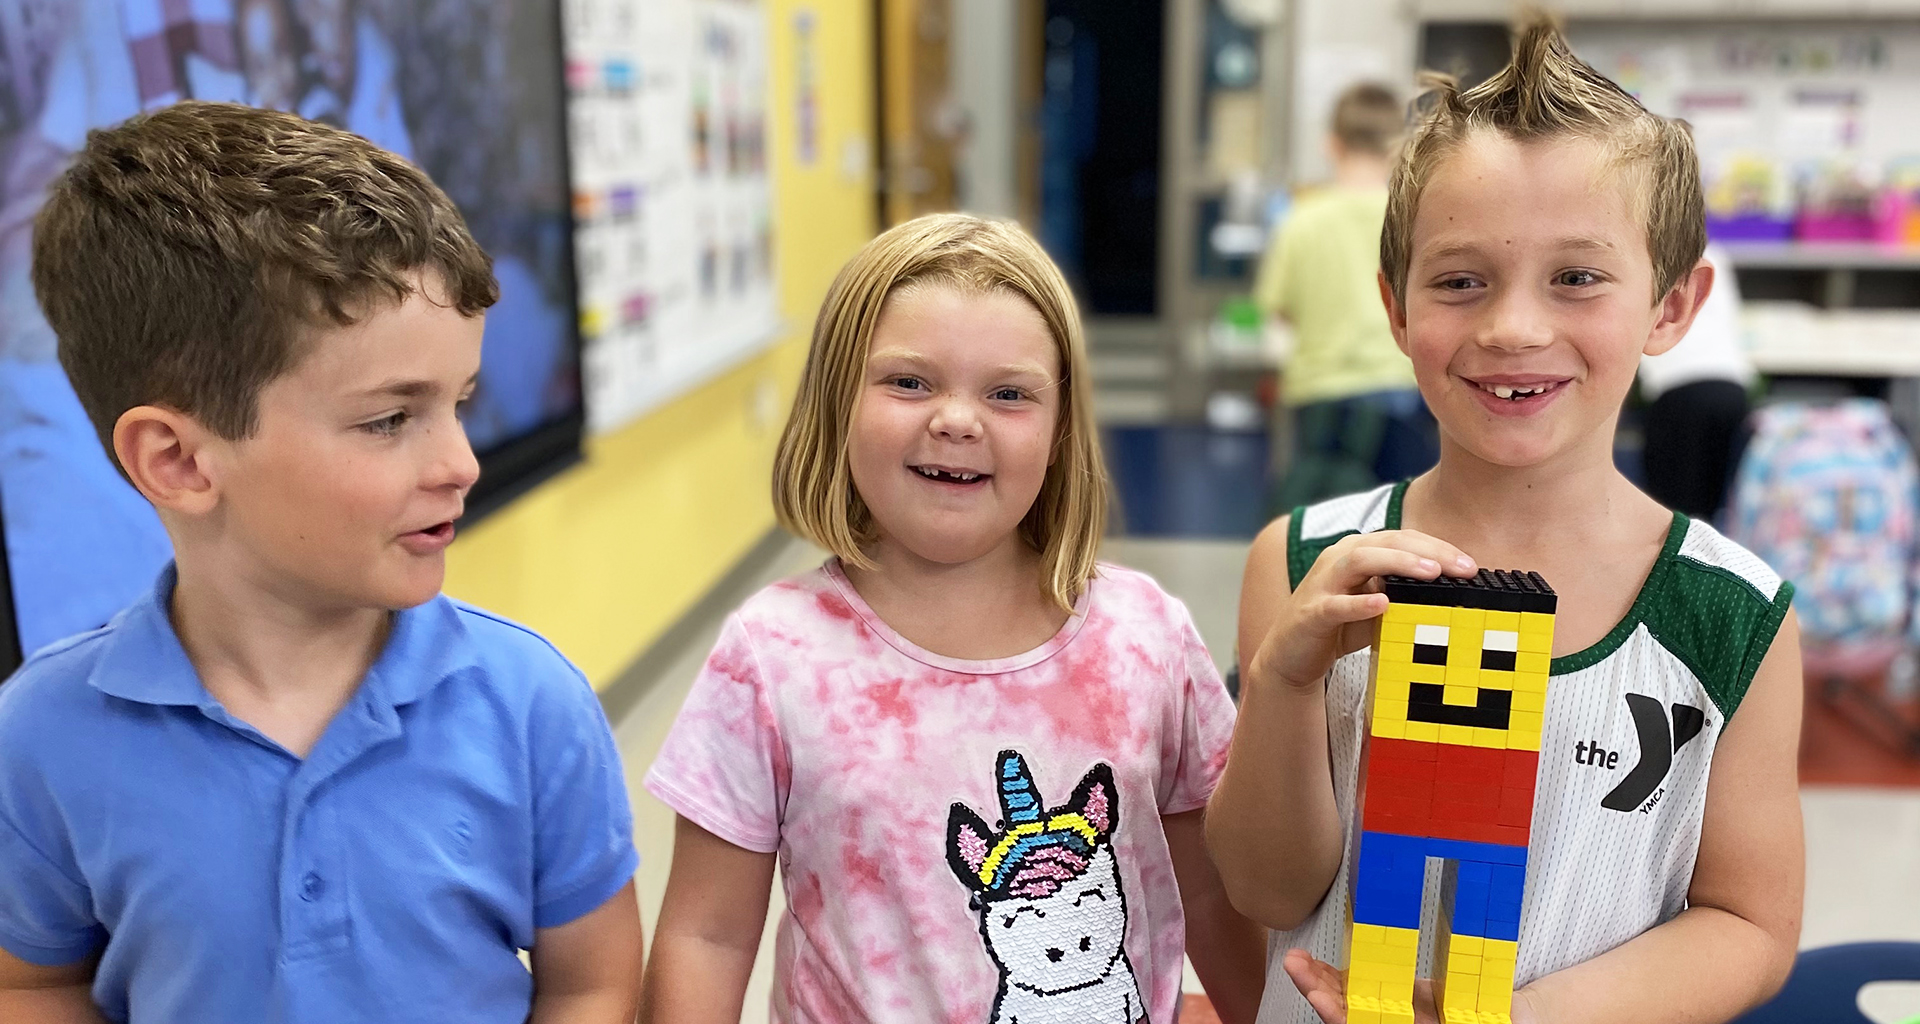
(528, 653, 639, 928)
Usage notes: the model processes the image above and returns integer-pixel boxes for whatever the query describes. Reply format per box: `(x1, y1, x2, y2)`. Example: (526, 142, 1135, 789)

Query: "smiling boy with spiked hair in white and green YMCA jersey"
(1208, 15, 1805, 1024)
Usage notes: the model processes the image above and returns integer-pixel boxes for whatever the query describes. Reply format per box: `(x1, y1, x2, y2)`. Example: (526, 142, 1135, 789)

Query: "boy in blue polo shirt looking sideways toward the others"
(0, 104, 641, 1024)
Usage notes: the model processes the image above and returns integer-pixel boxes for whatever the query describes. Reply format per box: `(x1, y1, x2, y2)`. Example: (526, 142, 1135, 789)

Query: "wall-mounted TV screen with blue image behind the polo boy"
(0, 0, 584, 678)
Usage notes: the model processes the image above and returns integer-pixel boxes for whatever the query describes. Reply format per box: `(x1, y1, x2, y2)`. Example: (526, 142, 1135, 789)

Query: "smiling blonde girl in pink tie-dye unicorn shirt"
(643, 215, 1265, 1024)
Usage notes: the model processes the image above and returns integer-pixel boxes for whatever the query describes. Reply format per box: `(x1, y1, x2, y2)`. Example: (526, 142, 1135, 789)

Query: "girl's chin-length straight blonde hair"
(774, 213, 1108, 611)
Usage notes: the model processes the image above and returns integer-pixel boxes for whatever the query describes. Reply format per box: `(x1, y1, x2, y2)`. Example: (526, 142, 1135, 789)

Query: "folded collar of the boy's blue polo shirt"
(86, 561, 476, 707)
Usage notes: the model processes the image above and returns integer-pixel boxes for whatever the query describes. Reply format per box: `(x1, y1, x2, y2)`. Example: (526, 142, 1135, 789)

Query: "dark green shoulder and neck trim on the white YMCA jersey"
(1286, 482, 1793, 720)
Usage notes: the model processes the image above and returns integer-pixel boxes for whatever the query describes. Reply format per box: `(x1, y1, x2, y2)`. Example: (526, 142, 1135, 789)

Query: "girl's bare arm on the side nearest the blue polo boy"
(639, 818, 774, 1024)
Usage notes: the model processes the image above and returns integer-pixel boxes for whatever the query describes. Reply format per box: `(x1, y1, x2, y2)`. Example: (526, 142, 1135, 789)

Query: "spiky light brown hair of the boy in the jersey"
(1380, 13, 1707, 304)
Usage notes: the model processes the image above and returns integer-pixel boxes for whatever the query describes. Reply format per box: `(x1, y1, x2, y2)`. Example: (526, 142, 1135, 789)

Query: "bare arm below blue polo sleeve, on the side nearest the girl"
(528, 882, 647, 1024)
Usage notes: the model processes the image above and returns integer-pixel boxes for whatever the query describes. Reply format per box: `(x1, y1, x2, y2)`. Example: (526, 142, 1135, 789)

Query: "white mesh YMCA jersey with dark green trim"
(1260, 484, 1793, 1024)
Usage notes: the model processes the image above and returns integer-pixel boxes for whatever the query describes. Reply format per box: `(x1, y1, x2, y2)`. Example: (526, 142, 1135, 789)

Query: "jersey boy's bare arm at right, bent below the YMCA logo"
(1526, 615, 1807, 1024)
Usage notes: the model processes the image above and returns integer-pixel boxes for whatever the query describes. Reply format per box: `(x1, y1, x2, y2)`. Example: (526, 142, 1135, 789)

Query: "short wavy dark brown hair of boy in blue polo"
(33, 102, 499, 465)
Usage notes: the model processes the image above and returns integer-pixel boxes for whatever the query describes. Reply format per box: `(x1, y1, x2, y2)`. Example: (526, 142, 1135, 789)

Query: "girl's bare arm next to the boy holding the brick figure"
(1160, 811, 1267, 1024)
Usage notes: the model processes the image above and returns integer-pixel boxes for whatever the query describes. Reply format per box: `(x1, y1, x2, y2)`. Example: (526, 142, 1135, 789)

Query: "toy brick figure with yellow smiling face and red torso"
(1346, 569, 1557, 1024)
